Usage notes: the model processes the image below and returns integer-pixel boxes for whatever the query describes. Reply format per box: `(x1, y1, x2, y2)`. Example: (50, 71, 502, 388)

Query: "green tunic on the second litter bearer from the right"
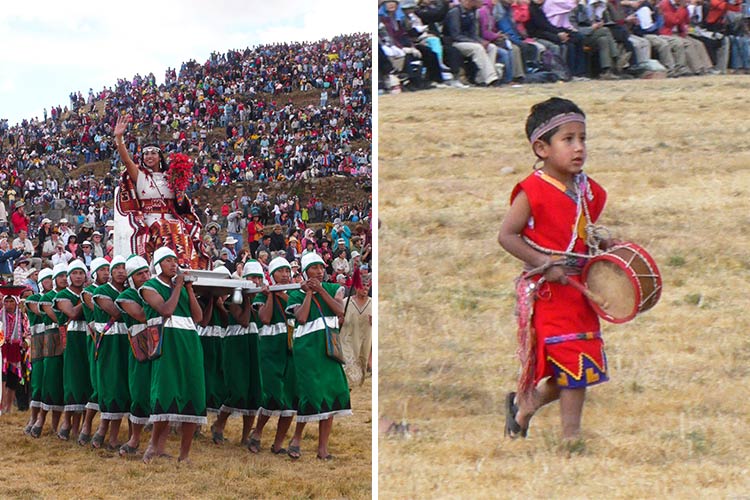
(253, 293, 295, 417)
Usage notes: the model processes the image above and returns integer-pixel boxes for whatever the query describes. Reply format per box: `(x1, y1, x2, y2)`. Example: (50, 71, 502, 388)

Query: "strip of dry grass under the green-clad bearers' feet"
(0, 380, 372, 499)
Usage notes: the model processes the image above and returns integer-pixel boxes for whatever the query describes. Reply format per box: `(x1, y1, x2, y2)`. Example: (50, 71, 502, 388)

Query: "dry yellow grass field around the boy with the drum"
(378, 76, 750, 498)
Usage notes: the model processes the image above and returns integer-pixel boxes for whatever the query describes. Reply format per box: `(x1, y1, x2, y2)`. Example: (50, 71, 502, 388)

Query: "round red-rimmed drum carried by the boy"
(581, 242, 662, 323)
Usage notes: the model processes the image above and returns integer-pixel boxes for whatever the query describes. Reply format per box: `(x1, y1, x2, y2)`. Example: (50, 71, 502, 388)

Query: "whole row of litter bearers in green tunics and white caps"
(25, 247, 351, 463)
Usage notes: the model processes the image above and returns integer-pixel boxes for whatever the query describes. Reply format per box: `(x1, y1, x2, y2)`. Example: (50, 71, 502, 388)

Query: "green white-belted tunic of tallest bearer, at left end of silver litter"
(138, 277, 208, 424)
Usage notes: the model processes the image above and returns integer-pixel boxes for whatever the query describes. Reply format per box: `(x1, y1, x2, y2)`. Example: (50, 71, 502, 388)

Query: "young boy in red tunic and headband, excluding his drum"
(498, 98, 608, 440)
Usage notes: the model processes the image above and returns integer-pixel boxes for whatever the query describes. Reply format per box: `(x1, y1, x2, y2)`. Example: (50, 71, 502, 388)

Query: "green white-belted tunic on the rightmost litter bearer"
(286, 283, 352, 422)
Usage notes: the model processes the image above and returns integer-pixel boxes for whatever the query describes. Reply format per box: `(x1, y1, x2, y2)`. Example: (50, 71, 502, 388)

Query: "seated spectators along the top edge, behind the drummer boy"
(378, 0, 750, 93)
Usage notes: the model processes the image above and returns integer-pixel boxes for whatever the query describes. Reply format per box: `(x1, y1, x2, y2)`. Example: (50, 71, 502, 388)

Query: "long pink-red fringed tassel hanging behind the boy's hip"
(516, 275, 536, 408)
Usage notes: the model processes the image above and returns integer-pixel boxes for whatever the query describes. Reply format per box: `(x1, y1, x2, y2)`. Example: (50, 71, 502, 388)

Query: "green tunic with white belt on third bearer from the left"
(54, 288, 91, 412)
